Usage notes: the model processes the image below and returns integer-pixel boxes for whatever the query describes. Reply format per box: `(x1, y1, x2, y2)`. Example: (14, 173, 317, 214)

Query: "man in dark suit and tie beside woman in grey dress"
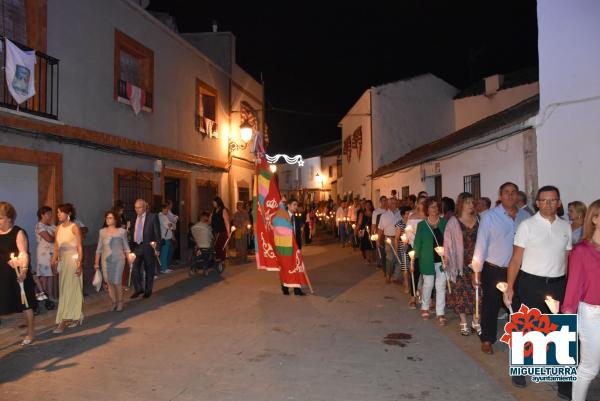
(131, 199, 161, 299)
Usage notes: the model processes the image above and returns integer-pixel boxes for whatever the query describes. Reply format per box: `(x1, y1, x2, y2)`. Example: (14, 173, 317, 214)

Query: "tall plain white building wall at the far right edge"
(535, 0, 600, 203)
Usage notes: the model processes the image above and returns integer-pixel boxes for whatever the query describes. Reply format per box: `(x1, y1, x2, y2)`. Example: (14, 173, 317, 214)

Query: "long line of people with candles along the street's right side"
(317, 182, 600, 400)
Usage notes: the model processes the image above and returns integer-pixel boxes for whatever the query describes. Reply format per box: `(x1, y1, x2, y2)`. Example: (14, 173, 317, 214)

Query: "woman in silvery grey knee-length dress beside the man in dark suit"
(94, 210, 130, 312)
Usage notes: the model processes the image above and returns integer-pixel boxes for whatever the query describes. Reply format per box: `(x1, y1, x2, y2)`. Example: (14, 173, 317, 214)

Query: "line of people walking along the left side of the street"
(0, 197, 251, 345)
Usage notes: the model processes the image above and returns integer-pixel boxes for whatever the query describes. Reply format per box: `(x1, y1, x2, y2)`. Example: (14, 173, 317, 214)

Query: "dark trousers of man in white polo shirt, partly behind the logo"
(512, 271, 572, 394)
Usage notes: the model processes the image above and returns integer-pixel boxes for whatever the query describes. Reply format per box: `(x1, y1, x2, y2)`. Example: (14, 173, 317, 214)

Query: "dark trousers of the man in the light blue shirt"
(479, 262, 506, 344)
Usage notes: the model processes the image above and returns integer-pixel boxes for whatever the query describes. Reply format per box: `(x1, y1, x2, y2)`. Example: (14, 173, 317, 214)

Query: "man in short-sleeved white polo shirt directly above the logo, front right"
(504, 185, 572, 399)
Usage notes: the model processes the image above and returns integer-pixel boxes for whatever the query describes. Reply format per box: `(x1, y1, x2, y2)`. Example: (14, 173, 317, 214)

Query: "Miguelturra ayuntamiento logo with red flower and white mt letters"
(500, 305, 579, 383)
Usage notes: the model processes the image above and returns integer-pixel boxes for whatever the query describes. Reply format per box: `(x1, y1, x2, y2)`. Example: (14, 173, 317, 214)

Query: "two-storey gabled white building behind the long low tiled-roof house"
(338, 74, 457, 198)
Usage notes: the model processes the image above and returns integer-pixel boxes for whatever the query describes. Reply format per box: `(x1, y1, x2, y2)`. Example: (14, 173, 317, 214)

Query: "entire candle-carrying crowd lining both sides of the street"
(0, 182, 600, 400)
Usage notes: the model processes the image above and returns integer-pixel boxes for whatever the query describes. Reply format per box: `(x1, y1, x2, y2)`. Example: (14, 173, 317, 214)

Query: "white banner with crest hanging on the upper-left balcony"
(5, 39, 35, 104)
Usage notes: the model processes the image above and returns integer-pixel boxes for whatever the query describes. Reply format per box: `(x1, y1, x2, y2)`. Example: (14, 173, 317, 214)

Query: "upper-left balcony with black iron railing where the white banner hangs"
(0, 36, 59, 120)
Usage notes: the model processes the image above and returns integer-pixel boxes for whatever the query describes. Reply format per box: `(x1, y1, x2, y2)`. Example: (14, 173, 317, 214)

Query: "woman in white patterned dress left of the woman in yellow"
(34, 206, 58, 310)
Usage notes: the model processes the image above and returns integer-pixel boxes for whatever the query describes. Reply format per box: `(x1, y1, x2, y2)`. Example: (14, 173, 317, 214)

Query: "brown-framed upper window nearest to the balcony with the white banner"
(114, 30, 154, 111)
